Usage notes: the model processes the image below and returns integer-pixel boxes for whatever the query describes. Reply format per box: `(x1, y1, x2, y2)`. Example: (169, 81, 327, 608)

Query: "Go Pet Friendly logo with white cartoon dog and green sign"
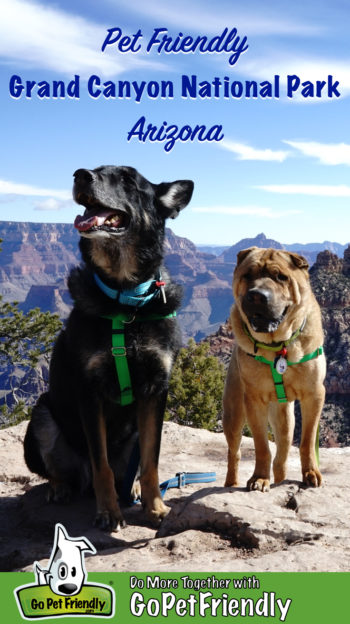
(15, 524, 114, 620)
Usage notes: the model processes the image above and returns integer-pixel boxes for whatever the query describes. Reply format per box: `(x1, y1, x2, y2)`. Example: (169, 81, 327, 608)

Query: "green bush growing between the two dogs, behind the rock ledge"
(165, 338, 225, 430)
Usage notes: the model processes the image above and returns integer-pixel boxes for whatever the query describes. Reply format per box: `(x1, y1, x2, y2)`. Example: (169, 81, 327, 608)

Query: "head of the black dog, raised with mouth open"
(73, 166, 193, 280)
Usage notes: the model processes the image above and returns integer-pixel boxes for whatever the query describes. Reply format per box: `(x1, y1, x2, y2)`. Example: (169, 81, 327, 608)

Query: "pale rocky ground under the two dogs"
(0, 423, 350, 572)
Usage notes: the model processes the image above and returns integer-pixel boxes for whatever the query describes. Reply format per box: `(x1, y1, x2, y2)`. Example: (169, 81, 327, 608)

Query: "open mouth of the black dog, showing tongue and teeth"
(74, 207, 129, 234)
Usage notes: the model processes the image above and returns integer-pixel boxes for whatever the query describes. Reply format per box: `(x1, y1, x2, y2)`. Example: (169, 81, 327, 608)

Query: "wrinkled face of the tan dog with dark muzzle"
(233, 247, 308, 333)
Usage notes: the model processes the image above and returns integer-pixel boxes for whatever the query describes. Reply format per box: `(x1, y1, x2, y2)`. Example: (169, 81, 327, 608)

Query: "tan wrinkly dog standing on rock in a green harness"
(223, 247, 326, 491)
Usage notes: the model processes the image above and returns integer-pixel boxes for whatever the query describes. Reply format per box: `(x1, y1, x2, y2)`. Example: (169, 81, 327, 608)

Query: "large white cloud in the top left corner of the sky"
(0, 0, 159, 77)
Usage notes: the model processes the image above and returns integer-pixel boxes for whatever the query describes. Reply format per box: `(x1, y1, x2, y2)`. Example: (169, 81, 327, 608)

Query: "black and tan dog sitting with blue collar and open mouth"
(24, 166, 193, 530)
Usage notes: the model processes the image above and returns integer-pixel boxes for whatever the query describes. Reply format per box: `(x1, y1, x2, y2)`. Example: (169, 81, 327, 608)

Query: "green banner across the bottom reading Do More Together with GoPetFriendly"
(0, 572, 350, 624)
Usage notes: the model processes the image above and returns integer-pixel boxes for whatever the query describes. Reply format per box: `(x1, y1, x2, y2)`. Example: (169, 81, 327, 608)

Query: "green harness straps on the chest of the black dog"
(103, 312, 176, 406)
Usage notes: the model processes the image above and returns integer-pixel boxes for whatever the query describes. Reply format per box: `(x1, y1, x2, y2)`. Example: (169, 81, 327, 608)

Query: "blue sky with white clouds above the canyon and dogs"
(0, 0, 350, 245)
